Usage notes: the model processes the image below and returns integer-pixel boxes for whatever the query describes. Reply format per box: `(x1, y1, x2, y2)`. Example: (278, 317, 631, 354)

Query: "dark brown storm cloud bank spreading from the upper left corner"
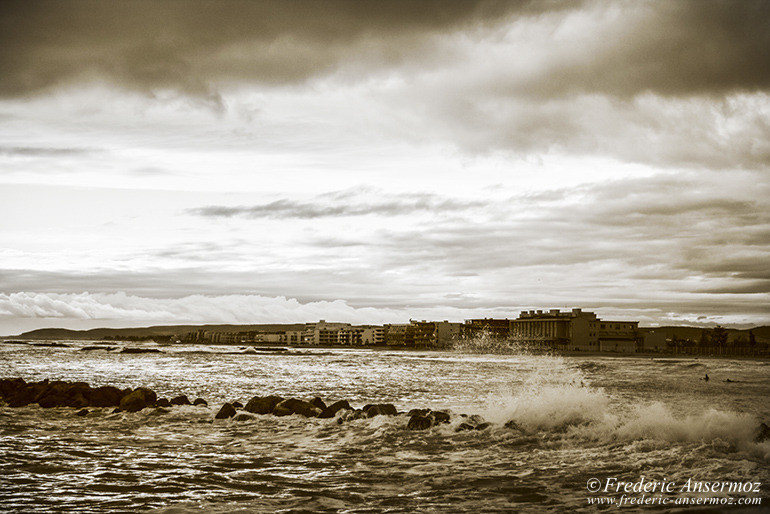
(0, 0, 544, 95)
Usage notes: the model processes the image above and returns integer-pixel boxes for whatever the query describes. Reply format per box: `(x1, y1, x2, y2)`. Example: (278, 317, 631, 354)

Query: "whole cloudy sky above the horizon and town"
(0, 0, 770, 335)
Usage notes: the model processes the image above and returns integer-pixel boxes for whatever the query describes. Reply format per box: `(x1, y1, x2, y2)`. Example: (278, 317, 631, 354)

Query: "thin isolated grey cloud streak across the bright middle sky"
(187, 195, 487, 219)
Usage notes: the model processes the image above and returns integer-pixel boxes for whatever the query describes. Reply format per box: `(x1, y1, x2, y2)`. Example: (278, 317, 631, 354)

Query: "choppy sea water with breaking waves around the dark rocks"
(0, 343, 770, 512)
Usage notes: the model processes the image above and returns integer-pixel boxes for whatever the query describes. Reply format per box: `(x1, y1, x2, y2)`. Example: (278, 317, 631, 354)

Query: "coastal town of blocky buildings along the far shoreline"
(171, 308, 768, 356)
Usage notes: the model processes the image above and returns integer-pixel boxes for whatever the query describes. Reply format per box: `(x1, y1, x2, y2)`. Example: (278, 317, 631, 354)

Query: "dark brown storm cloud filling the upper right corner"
(523, 0, 770, 96)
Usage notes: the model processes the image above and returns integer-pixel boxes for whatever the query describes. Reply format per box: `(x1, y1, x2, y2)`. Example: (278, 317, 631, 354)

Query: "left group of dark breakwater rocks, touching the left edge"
(0, 378, 208, 416)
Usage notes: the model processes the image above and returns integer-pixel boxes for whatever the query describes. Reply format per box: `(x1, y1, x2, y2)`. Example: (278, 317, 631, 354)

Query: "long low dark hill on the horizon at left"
(6, 323, 305, 340)
